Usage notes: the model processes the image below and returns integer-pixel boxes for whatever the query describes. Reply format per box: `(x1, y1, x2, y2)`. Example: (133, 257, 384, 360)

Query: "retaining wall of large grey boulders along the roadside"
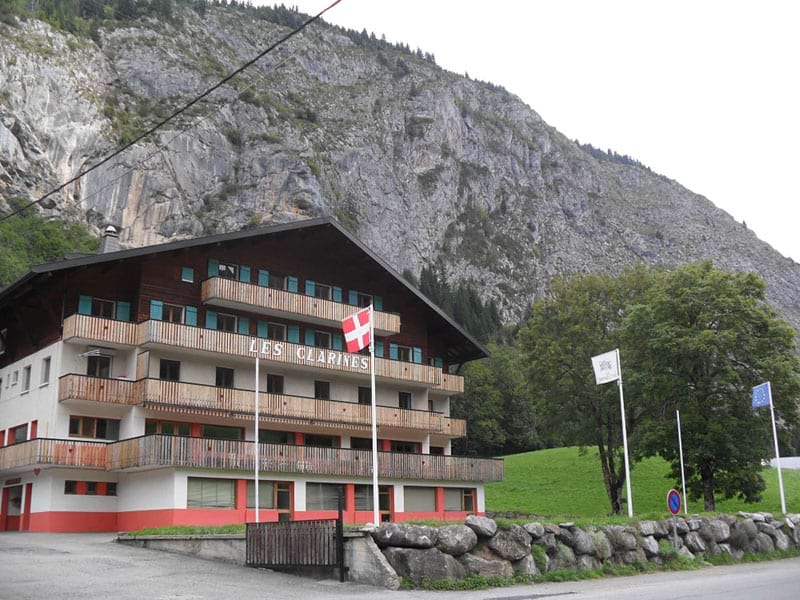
(372, 513, 800, 588)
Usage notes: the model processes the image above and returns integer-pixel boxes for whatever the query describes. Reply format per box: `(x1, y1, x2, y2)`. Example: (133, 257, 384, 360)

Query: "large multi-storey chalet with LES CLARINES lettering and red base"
(0, 219, 503, 531)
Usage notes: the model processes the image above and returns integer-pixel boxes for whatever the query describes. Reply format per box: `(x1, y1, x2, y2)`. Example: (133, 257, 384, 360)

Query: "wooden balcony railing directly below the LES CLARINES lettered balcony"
(58, 374, 467, 437)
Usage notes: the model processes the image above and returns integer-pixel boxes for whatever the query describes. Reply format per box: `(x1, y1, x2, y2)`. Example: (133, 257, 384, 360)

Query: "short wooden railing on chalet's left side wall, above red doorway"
(0, 438, 108, 471)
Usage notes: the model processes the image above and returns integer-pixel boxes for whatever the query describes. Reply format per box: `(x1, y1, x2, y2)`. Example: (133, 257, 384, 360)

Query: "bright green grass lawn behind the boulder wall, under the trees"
(486, 448, 800, 518)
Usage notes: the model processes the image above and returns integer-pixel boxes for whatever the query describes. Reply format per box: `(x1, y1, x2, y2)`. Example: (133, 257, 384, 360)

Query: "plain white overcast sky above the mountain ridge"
(288, 0, 800, 261)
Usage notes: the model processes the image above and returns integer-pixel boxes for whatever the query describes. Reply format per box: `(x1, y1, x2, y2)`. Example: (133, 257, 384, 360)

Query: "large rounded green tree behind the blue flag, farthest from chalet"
(625, 262, 800, 511)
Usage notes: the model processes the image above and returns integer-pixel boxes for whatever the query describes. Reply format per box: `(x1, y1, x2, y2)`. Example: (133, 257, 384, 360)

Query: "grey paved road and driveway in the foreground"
(0, 533, 800, 600)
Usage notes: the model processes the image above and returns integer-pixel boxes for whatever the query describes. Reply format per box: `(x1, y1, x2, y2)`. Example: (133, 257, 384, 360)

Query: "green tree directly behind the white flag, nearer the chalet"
(519, 267, 657, 513)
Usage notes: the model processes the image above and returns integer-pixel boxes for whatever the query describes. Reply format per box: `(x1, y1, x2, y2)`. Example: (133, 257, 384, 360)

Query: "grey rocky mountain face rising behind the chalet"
(0, 7, 800, 327)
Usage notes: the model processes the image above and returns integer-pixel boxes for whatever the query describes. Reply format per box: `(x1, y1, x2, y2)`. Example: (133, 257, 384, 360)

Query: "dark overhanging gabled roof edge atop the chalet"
(0, 217, 489, 361)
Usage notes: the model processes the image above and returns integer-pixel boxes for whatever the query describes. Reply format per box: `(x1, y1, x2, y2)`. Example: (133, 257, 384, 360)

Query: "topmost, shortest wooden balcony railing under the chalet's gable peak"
(202, 277, 400, 335)
